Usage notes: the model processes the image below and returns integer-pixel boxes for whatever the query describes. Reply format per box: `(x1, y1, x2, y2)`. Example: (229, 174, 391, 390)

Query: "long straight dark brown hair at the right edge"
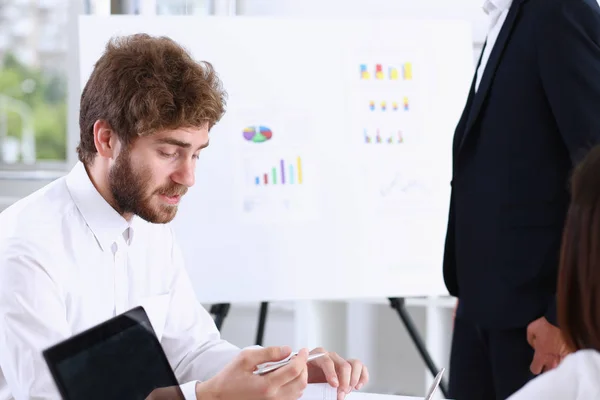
(557, 146, 600, 351)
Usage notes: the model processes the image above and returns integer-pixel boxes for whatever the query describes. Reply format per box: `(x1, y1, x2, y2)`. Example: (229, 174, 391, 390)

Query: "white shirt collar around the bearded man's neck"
(66, 162, 136, 251)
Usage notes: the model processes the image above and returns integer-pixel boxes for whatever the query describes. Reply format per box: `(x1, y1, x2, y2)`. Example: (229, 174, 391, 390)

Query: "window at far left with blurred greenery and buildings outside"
(0, 0, 69, 168)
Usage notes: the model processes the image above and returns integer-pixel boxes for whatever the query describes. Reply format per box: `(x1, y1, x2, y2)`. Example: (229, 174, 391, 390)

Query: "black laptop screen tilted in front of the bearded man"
(43, 307, 184, 400)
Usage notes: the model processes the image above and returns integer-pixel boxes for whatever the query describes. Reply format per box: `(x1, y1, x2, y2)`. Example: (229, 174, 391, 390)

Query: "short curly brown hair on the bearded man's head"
(77, 34, 226, 164)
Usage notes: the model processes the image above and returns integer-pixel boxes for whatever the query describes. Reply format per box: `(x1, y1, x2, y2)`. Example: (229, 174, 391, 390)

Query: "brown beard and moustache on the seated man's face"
(108, 148, 187, 224)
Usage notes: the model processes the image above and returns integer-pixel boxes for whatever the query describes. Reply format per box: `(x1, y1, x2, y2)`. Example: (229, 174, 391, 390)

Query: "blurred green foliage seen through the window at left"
(0, 53, 67, 160)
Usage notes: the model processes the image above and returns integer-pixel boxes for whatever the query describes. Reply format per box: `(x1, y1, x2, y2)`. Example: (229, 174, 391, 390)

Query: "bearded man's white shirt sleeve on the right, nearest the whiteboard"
(161, 230, 241, 383)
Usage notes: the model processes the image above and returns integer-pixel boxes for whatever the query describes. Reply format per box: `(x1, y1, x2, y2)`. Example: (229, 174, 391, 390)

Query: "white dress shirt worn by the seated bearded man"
(0, 163, 240, 400)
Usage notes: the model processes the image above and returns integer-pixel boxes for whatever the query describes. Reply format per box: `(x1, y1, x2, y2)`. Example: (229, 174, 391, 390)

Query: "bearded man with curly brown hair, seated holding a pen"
(0, 34, 368, 400)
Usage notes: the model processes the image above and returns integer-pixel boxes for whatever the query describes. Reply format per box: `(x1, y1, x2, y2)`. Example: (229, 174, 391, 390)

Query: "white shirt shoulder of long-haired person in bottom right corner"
(508, 350, 600, 400)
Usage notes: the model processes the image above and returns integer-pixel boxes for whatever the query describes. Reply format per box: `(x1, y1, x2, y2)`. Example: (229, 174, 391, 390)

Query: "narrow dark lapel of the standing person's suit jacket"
(458, 0, 523, 150)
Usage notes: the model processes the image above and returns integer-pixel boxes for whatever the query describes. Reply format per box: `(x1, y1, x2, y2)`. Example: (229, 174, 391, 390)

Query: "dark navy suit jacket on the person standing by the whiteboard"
(444, 0, 600, 328)
